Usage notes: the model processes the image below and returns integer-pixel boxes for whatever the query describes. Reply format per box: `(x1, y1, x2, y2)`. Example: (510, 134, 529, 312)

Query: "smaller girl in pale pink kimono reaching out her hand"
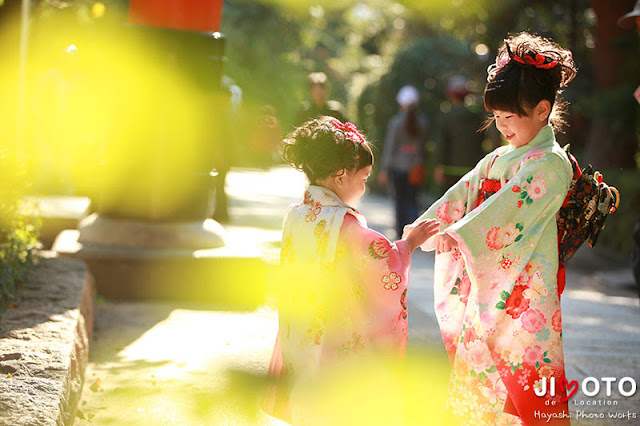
(263, 116, 438, 424)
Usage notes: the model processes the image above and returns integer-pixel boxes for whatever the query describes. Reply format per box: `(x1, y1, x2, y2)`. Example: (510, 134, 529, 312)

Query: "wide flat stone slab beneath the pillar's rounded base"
(53, 230, 267, 309)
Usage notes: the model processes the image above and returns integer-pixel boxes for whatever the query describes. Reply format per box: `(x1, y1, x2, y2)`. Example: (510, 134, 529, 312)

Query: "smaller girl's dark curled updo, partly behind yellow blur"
(282, 116, 373, 184)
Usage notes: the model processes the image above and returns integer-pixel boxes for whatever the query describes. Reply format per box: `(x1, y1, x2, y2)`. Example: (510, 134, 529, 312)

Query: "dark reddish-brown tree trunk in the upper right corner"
(587, 0, 640, 169)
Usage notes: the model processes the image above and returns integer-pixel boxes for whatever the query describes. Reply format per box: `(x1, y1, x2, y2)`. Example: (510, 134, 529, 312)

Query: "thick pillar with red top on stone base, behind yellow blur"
(54, 0, 265, 307)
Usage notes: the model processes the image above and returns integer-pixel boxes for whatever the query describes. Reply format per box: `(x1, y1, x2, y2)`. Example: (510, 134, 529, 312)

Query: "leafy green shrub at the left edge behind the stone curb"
(0, 147, 37, 312)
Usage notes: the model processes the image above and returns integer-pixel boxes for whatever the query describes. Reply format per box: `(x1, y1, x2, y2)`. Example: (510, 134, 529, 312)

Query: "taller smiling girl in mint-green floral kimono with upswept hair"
(407, 33, 576, 425)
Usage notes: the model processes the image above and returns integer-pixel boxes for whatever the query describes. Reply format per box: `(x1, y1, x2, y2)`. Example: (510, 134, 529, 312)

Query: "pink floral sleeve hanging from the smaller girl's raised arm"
(335, 215, 411, 358)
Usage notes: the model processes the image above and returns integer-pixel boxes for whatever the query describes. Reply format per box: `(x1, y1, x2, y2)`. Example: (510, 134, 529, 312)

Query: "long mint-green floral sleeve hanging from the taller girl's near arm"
(446, 152, 571, 424)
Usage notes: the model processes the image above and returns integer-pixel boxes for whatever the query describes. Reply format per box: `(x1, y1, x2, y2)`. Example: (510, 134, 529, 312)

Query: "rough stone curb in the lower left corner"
(0, 252, 95, 425)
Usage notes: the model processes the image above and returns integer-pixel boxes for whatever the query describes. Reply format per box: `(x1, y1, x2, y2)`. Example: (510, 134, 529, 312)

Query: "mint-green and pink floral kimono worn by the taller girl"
(417, 126, 571, 425)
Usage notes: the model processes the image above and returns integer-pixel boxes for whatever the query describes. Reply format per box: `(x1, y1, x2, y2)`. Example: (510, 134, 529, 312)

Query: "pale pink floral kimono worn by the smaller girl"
(263, 185, 411, 423)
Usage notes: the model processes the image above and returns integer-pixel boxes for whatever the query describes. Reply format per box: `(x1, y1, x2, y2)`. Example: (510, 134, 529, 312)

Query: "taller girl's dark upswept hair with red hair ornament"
(484, 32, 578, 131)
